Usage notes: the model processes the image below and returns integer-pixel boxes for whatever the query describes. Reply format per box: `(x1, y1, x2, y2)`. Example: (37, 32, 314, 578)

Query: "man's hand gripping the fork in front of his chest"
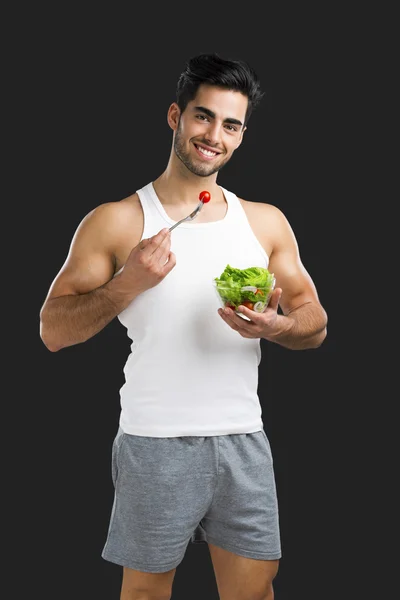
(121, 228, 176, 293)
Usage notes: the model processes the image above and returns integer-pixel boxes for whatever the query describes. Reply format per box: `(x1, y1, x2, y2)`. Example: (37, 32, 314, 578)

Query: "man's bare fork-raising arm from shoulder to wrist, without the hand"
(40, 204, 134, 352)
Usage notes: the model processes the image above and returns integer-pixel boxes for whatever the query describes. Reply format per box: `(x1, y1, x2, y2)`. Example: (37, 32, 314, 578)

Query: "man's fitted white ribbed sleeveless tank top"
(118, 183, 269, 437)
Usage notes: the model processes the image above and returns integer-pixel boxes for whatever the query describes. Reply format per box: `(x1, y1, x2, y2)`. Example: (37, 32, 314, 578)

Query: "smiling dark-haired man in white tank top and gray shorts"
(40, 54, 327, 600)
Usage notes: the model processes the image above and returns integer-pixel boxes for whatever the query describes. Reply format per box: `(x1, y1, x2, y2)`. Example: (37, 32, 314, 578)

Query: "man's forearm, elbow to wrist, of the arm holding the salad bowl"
(266, 302, 328, 350)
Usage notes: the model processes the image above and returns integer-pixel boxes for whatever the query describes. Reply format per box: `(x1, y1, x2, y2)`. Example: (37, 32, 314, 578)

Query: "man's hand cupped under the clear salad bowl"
(218, 288, 282, 338)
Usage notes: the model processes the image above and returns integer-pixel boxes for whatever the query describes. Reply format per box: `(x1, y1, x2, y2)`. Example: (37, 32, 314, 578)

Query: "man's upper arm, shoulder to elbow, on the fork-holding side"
(46, 209, 114, 301)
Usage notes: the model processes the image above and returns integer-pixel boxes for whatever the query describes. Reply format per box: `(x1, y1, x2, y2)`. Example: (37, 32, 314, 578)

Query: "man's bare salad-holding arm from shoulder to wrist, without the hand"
(266, 208, 328, 350)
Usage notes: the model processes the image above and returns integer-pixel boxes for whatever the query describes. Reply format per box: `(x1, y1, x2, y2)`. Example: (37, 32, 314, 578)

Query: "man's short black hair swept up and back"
(176, 52, 264, 125)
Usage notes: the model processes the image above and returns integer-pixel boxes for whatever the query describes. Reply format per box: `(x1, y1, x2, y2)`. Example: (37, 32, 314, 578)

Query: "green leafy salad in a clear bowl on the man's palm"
(214, 264, 275, 312)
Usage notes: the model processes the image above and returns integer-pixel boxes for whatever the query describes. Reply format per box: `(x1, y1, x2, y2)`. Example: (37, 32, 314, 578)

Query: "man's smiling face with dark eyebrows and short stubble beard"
(174, 84, 248, 177)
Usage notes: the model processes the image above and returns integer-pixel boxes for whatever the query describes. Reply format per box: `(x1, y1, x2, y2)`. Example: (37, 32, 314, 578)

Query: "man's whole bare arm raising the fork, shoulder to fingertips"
(40, 203, 175, 352)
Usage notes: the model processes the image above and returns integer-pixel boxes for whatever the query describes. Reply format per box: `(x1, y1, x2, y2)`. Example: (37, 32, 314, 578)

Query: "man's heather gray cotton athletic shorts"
(101, 428, 281, 573)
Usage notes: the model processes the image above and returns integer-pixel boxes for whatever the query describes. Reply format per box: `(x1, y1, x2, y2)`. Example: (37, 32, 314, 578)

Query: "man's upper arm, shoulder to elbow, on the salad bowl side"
(268, 212, 319, 315)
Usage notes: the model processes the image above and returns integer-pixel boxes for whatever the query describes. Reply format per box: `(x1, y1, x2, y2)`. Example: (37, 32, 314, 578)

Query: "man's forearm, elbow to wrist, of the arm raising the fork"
(40, 275, 137, 352)
